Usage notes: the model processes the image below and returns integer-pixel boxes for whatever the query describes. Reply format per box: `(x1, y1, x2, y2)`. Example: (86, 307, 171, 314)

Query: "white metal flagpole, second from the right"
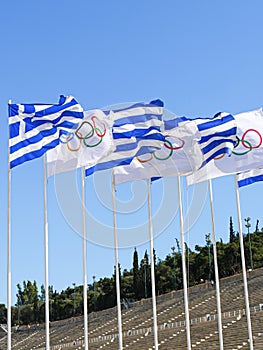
(208, 179, 224, 350)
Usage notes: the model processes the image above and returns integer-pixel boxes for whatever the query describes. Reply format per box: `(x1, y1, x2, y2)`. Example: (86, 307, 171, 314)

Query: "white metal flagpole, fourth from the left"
(111, 171, 123, 350)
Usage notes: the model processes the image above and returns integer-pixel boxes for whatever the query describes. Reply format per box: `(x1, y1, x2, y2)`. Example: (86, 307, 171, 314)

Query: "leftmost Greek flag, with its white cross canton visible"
(9, 96, 83, 168)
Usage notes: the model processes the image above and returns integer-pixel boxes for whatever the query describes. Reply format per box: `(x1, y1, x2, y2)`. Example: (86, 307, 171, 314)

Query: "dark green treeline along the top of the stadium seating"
(0, 218, 263, 324)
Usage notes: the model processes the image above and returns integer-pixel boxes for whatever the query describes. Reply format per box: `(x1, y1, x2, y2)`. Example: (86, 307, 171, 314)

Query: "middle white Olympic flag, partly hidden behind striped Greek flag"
(114, 118, 204, 184)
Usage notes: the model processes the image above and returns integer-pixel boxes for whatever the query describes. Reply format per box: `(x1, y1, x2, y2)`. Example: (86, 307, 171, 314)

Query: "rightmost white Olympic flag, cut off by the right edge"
(187, 108, 263, 185)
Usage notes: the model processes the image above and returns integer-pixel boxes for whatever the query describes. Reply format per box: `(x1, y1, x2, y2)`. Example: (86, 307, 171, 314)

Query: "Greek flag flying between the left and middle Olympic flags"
(86, 100, 164, 176)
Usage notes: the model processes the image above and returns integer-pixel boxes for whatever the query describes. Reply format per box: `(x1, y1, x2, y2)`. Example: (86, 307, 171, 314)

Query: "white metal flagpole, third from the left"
(81, 167, 89, 350)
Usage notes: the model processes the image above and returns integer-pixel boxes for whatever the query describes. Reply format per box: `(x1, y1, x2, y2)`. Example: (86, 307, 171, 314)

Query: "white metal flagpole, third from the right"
(177, 176, 191, 350)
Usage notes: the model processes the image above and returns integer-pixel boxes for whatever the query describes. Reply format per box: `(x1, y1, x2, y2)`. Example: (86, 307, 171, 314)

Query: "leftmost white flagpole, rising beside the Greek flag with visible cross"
(7, 100, 12, 350)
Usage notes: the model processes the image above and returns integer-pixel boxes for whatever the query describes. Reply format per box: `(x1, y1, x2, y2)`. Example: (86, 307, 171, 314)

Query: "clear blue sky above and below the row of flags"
(0, 0, 263, 303)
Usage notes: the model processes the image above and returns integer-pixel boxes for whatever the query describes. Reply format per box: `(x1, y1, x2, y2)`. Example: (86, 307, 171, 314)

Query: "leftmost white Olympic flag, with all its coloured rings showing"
(47, 110, 115, 176)
